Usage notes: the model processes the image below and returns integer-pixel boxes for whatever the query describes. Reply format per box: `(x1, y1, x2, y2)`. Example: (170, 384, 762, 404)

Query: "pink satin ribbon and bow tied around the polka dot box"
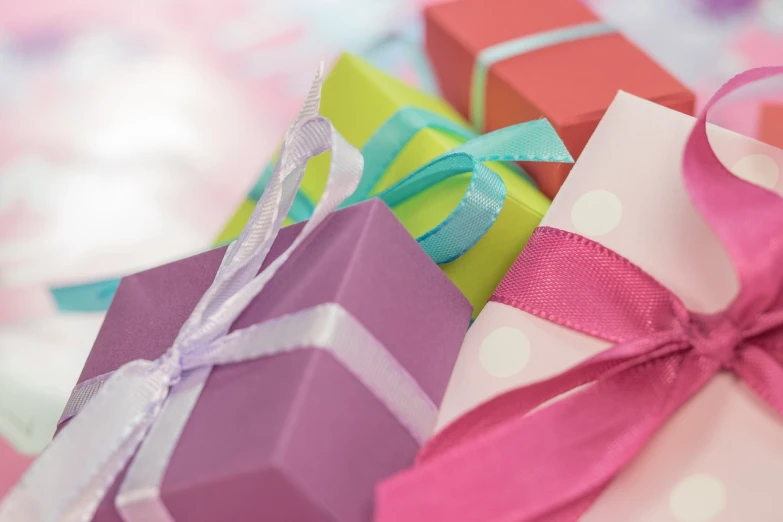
(376, 67, 783, 522)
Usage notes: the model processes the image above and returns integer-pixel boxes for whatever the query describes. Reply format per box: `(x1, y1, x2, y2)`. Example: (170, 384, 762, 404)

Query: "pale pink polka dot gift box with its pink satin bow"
(376, 68, 783, 522)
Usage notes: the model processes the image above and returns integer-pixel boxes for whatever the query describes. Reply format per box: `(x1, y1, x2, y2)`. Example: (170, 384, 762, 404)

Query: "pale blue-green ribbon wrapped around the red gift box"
(470, 22, 617, 132)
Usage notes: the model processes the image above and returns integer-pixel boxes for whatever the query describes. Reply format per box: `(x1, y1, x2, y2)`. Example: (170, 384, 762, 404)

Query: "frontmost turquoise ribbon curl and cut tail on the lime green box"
(378, 120, 573, 264)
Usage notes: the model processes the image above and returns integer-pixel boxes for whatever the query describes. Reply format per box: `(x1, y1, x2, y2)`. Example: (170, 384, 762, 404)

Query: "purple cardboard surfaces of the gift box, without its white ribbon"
(67, 200, 471, 522)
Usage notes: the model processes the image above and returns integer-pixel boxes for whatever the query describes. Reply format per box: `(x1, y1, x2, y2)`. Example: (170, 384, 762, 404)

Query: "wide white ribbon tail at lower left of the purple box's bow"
(0, 361, 169, 522)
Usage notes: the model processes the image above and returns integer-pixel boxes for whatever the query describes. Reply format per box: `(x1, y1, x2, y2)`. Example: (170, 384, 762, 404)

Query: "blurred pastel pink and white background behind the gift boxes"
(0, 0, 783, 495)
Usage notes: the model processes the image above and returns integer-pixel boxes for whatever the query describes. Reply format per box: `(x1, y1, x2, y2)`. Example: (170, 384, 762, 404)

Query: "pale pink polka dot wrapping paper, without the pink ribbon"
(439, 93, 783, 522)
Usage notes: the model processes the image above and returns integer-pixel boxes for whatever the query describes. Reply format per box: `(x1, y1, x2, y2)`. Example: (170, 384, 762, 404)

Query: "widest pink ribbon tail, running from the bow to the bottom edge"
(376, 355, 719, 522)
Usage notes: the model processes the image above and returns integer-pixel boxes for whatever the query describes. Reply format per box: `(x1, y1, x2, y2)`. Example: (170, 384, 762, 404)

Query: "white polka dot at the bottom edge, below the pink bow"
(669, 473, 726, 522)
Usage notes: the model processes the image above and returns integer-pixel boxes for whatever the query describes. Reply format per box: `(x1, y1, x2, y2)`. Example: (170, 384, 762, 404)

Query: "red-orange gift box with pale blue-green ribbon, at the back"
(425, 0, 694, 197)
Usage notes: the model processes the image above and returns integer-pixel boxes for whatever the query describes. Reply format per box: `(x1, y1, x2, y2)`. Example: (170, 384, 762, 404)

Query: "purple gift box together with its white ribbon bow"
(0, 83, 471, 522)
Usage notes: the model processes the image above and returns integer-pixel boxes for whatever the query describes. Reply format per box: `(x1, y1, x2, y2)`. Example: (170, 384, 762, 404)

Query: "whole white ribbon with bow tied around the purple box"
(0, 66, 435, 522)
